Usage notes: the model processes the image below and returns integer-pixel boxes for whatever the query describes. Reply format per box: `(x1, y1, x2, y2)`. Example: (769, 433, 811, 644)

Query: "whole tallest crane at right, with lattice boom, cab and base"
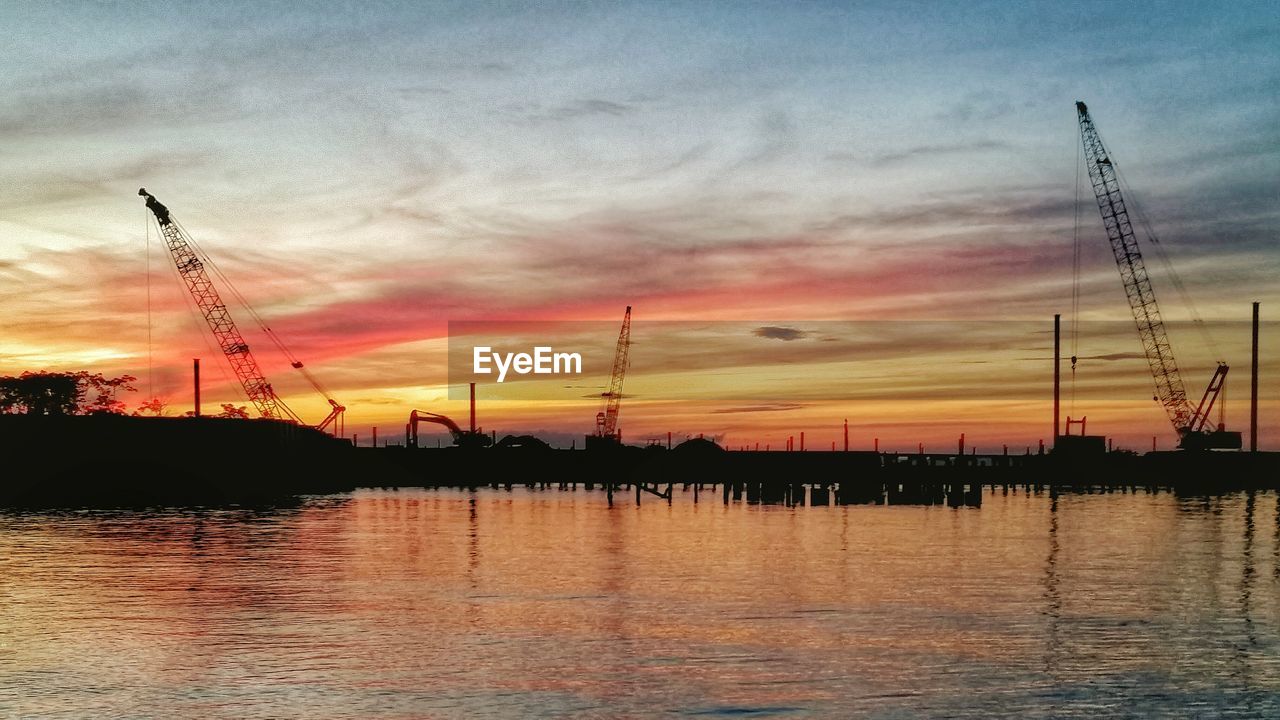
(1073, 101, 1240, 450)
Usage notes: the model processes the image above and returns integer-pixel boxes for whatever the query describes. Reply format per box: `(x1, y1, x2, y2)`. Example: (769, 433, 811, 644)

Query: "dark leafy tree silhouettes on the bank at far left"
(0, 370, 137, 415)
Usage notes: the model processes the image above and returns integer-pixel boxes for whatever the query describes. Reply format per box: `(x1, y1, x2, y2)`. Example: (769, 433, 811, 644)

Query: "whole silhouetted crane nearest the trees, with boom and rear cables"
(138, 187, 347, 430)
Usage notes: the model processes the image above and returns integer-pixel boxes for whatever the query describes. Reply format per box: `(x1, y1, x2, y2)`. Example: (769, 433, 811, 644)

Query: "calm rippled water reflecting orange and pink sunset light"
(0, 489, 1280, 719)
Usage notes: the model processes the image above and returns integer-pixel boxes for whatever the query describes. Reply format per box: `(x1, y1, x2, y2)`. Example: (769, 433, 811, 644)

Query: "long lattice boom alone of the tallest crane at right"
(1075, 102, 1198, 436)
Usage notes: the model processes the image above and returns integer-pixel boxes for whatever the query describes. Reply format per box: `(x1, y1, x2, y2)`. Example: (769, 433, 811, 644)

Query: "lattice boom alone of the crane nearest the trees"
(138, 187, 298, 420)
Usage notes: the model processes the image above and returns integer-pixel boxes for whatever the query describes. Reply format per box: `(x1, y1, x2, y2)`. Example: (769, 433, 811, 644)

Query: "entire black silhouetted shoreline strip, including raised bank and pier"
(0, 415, 1280, 506)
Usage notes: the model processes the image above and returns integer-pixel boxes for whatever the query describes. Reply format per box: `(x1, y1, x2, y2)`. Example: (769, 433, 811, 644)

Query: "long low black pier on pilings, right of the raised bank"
(357, 447, 1280, 507)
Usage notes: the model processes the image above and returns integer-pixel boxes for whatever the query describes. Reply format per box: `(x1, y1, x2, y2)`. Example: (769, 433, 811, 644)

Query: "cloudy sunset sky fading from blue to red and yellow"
(0, 0, 1280, 450)
